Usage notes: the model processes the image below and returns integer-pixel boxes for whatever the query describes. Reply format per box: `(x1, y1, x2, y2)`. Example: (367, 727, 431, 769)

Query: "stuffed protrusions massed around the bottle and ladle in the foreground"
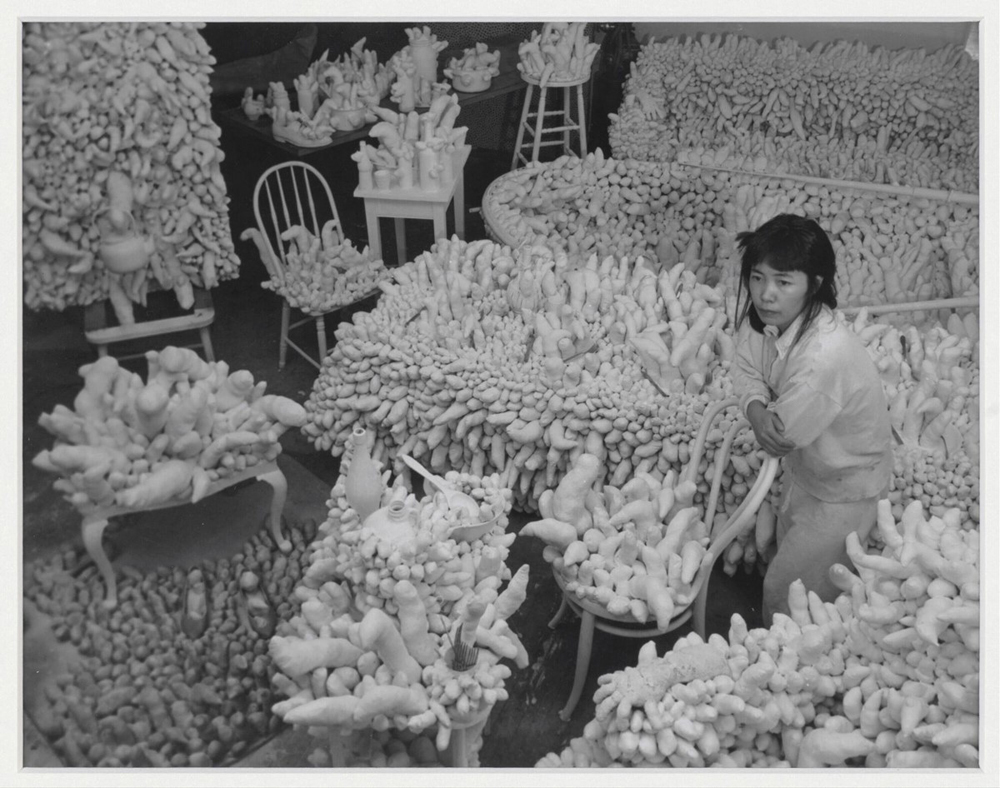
(269, 452, 530, 751)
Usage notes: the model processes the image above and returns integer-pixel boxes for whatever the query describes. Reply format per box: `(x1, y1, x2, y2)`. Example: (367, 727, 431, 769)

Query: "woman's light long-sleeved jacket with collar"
(732, 308, 892, 502)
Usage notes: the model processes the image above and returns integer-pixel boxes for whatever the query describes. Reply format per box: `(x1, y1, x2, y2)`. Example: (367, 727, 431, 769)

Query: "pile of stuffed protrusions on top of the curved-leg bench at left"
(33, 345, 307, 509)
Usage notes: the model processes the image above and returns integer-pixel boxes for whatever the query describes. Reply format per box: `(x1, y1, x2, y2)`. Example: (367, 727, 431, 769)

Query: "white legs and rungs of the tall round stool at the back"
(510, 73, 590, 170)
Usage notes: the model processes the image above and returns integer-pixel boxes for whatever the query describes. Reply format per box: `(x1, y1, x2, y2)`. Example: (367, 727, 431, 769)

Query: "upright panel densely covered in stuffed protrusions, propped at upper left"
(23, 21, 239, 318)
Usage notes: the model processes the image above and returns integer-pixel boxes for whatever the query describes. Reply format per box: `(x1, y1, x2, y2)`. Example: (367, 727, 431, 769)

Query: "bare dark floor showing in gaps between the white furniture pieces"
(22, 107, 760, 767)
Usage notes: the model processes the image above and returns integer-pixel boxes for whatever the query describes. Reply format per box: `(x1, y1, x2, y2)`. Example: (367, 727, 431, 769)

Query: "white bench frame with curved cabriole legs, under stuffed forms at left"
(79, 460, 292, 609)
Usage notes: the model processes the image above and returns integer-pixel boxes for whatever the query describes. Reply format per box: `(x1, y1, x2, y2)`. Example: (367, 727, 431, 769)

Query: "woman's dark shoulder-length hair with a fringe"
(736, 213, 837, 342)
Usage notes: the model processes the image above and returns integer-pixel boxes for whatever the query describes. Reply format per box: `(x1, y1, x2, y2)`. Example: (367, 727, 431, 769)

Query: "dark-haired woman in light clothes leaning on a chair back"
(734, 214, 892, 626)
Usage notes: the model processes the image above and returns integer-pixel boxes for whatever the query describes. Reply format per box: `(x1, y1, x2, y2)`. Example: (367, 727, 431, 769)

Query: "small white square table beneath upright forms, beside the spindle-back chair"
(354, 145, 471, 265)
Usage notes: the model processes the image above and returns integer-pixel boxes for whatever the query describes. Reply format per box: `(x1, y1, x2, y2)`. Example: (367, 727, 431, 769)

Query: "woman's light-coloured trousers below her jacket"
(763, 478, 884, 627)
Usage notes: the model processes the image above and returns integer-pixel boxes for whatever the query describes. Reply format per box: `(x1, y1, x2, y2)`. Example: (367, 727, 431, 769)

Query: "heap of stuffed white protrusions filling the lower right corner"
(538, 500, 980, 768)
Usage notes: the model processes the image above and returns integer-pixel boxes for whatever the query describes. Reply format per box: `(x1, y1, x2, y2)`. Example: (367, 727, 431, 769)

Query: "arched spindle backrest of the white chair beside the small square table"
(253, 161, 343, 265)
